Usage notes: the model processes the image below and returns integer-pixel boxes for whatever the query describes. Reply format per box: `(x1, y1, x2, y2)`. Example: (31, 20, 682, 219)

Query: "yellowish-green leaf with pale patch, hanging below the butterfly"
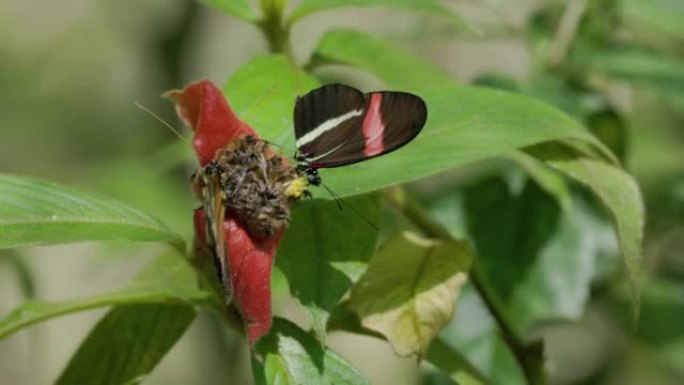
(349, 233, 472, 356)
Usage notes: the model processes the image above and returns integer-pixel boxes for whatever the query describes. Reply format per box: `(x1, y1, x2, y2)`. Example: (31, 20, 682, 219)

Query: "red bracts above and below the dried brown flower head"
(165, 80, 283, 343)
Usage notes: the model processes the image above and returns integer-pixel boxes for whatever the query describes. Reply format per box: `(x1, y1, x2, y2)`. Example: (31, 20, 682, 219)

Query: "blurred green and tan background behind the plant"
(0, 0, 684, 384)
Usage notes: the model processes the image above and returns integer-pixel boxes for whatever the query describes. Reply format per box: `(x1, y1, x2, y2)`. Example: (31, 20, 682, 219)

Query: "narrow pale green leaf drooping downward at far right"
(528, 144, 644, 316)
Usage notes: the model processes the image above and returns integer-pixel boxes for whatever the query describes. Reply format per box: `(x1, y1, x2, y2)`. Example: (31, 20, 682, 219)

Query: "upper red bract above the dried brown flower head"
(164, 79, 258, 166)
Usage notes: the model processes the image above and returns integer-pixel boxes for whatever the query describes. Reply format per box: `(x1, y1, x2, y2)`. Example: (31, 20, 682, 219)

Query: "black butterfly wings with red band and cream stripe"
(295, 84, 427, 168)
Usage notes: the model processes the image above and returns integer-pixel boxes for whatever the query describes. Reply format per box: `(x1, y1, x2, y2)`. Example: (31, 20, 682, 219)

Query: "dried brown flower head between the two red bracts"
(192, 135, 306, 238)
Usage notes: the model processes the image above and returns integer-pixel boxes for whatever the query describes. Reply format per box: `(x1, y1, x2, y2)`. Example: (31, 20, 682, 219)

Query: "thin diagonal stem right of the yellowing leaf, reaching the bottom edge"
(385, 187, 547, 385)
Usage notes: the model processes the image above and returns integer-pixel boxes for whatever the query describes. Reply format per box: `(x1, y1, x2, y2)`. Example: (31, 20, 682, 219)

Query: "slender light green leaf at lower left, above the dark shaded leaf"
(0, 253, 210, 339)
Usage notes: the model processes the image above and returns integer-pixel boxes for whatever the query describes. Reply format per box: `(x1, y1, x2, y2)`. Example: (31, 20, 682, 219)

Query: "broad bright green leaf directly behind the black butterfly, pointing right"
(323, 87, 616, 196)
